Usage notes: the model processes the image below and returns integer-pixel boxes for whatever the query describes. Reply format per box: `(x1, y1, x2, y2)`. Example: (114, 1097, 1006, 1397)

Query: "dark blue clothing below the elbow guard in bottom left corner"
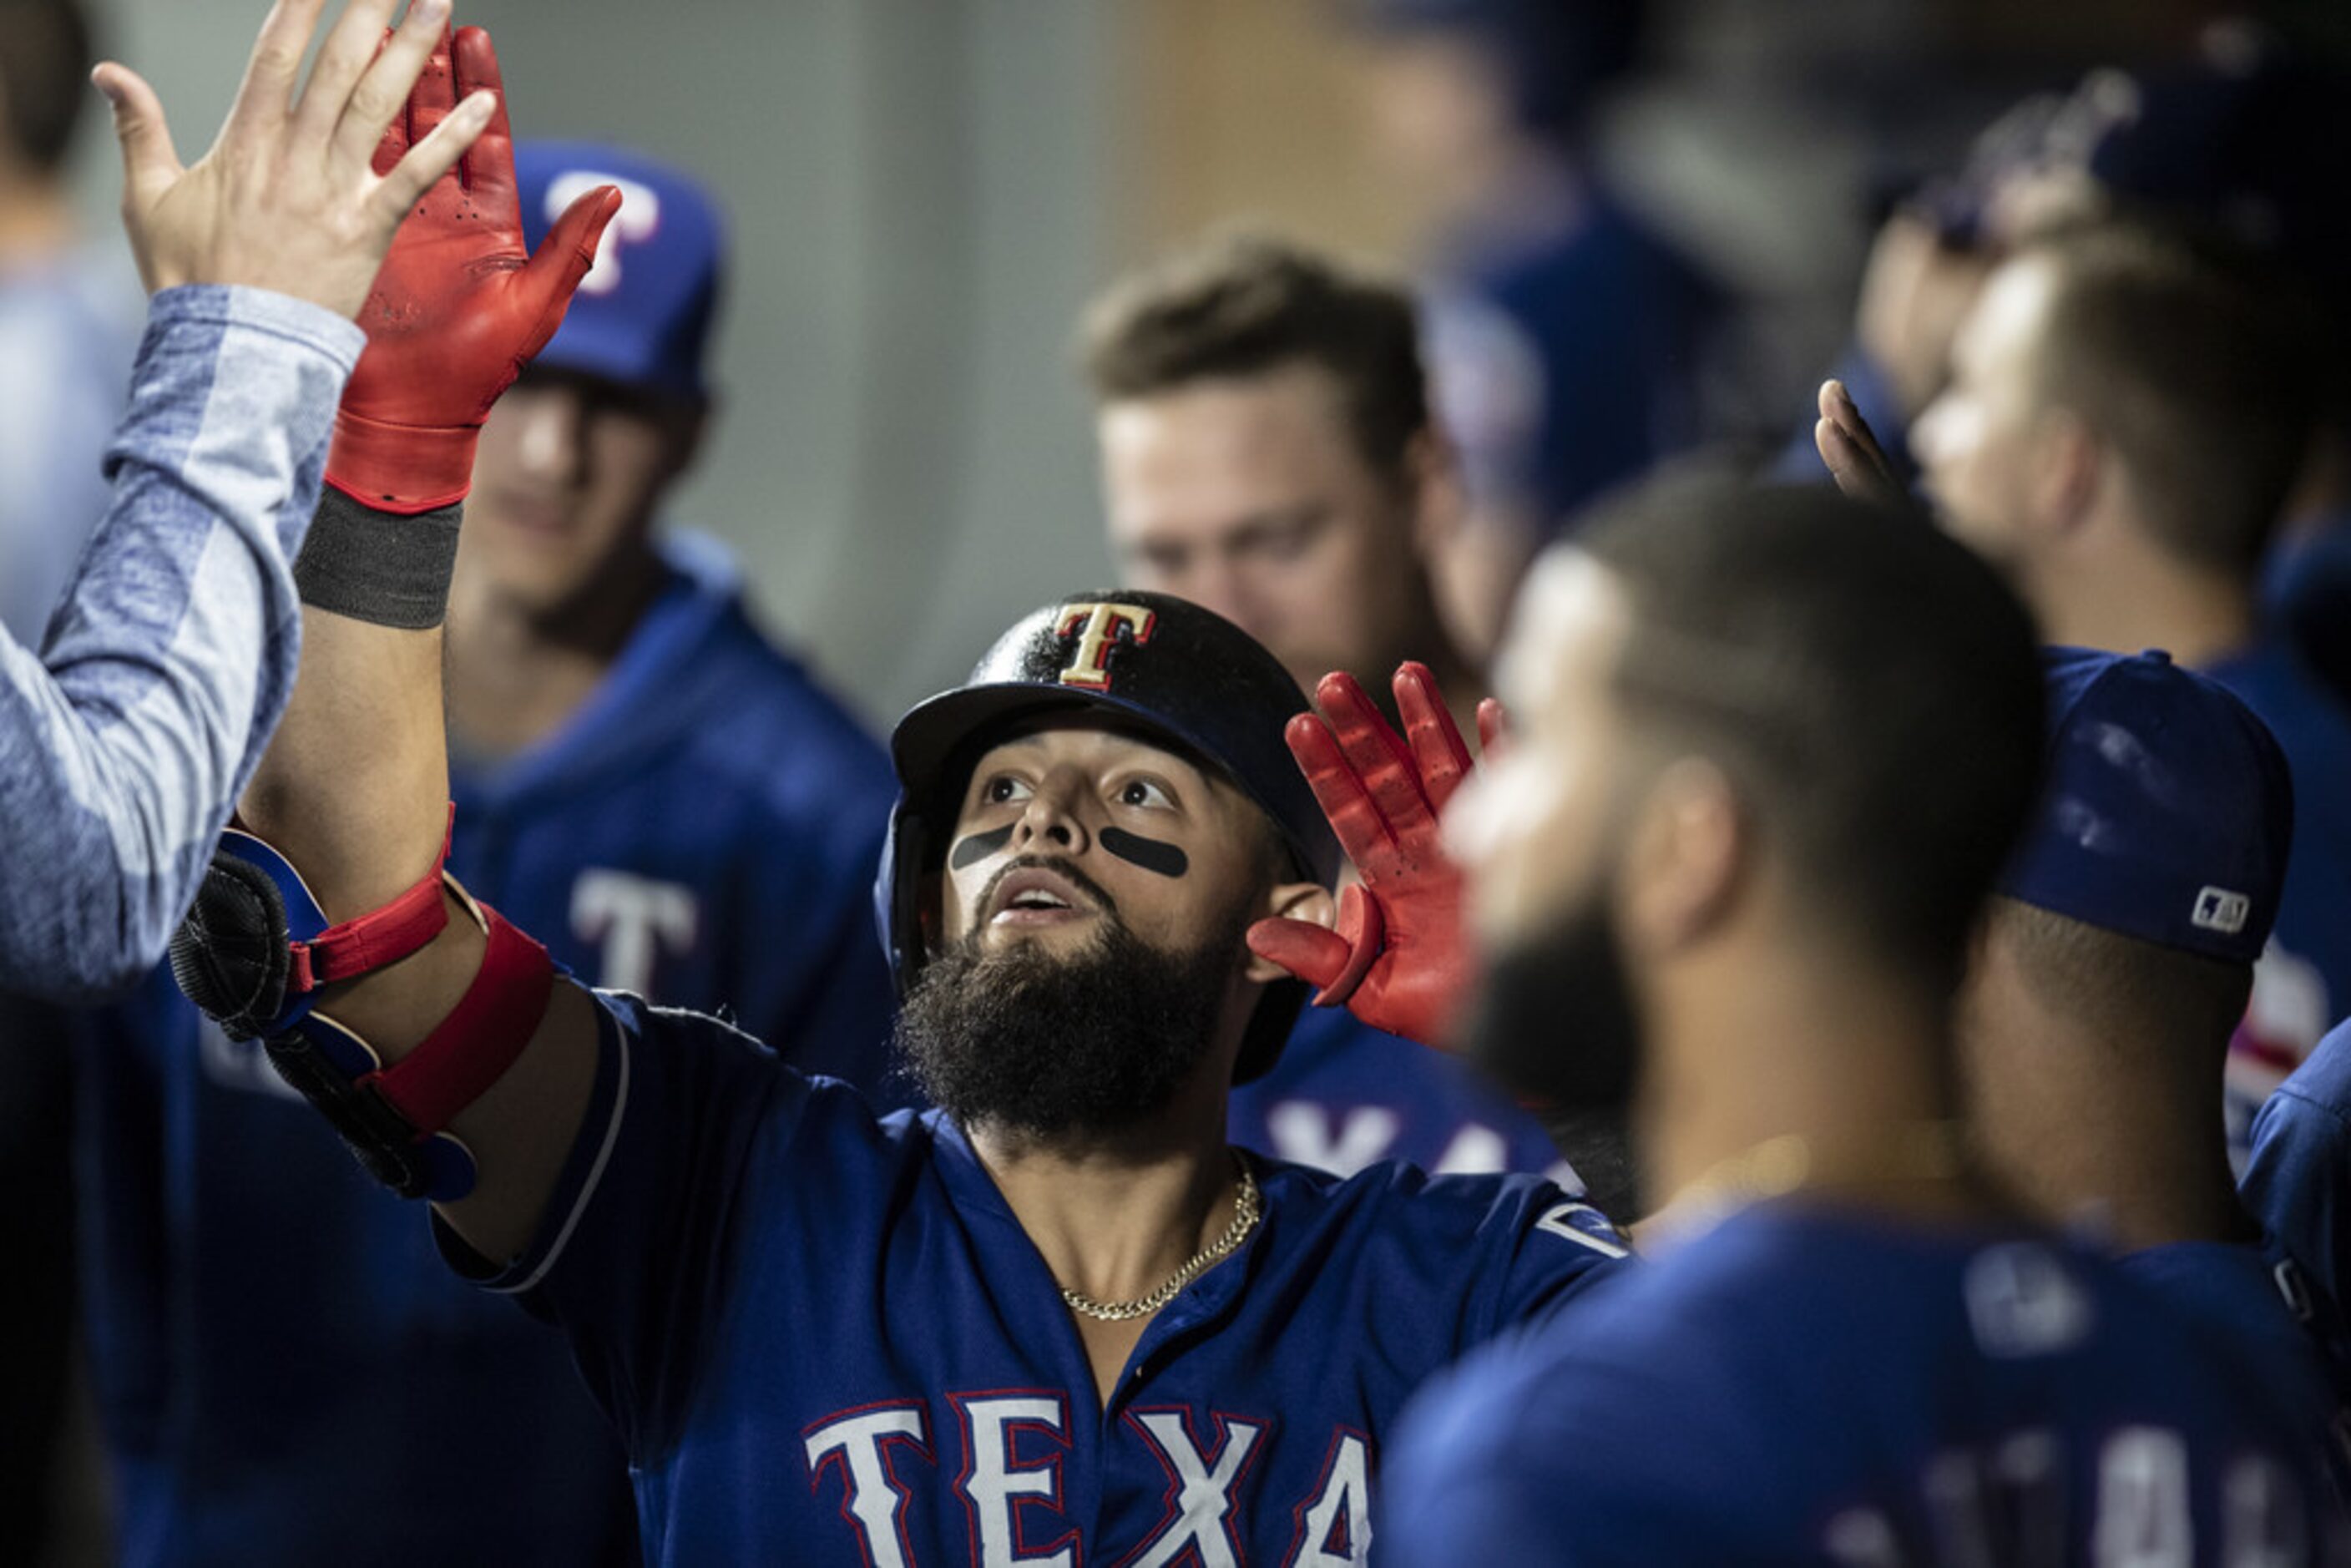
(73, 971, 635, 1568)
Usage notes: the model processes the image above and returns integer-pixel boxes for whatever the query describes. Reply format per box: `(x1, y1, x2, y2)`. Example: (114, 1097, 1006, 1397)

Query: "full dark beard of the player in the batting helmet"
(898, 905, 1248, 1142)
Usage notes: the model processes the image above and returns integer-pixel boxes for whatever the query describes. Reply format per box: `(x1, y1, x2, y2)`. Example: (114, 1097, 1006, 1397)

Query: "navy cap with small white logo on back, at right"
(1999, 649, 2294, 964)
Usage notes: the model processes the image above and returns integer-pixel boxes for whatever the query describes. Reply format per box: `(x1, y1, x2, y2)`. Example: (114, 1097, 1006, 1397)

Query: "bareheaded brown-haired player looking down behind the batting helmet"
(1084, 235, 1564, 1176)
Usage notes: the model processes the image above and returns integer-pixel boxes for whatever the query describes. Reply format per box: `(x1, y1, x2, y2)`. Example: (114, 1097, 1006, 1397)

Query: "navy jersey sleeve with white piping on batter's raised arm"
(432, 992, 817, 1462)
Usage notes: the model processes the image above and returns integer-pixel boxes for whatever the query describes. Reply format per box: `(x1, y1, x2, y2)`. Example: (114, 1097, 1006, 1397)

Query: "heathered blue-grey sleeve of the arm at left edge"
(0, 287, 367, 999)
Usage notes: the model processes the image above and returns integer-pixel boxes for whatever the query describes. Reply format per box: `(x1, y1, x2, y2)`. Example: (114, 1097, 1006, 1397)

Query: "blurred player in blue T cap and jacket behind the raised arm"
(59, 144, 893, 1563)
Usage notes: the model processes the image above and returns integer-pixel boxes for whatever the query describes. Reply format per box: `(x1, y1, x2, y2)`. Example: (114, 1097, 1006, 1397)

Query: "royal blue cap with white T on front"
(515, 141, 726, 400)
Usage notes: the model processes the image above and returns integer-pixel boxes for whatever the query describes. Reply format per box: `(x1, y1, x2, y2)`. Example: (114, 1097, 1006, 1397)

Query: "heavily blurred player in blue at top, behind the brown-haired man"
(1357, 0, 1731, 660)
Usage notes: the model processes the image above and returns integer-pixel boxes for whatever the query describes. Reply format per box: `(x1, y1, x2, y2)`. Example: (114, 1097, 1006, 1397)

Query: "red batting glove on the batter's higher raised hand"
(326, 28, 620, 513)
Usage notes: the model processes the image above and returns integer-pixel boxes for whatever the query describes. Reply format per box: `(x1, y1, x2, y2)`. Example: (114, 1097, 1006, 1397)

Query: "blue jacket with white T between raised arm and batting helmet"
(449, 531, 898, 1093)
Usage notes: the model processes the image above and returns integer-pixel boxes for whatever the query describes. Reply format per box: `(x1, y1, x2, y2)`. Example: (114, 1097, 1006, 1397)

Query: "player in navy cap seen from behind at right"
(1959, 649, 2351, 1434)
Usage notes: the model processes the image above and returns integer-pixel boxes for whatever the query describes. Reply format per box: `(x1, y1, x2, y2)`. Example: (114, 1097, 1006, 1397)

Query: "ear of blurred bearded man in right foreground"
(1620, 757, 1752, 954)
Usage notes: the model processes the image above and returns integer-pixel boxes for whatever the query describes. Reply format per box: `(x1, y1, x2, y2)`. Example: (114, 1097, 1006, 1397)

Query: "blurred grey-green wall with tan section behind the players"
(55, 0, 2266, 721)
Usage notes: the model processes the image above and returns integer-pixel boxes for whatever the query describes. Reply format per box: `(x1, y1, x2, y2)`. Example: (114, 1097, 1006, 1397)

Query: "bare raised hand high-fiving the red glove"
(92, 0, 496, 315)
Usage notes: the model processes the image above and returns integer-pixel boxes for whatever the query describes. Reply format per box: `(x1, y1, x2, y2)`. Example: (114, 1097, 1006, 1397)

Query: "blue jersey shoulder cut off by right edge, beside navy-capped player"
(2238, 1023, 2351, 1366)
